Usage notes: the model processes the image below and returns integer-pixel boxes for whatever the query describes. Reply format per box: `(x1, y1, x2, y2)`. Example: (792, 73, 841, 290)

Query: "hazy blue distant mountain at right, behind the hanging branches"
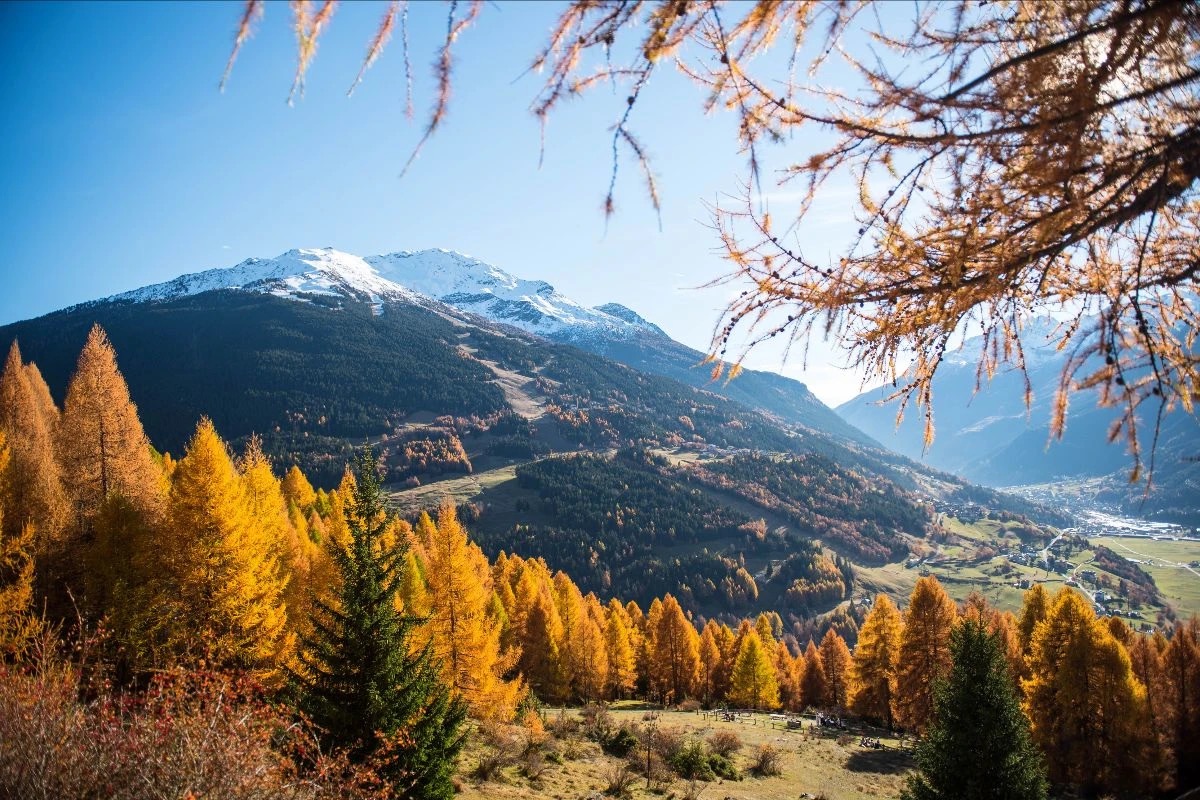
(838, 321, 1200, 519)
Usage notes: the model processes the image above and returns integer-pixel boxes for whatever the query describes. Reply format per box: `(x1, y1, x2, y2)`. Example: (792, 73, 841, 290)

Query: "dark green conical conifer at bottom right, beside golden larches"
(901, 619, 1046, 800)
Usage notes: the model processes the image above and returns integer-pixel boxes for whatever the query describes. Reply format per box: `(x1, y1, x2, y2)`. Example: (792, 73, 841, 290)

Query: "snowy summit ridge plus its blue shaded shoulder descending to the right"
(88, 247, 870, 443)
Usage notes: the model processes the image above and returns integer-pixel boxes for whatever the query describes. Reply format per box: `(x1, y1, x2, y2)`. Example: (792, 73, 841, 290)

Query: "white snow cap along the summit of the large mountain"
(97, 247, 662, 341)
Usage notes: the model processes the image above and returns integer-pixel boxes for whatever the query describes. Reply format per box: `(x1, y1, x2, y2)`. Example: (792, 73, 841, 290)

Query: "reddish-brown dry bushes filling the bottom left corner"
(0, 658, 383, 800)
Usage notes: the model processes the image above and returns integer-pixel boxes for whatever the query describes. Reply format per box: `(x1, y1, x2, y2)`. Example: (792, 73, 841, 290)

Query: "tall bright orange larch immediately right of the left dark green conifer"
(426, 503, 524, 722)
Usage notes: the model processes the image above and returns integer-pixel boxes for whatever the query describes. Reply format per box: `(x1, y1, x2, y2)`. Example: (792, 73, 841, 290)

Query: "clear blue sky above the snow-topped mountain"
(0, 2, 873, 403)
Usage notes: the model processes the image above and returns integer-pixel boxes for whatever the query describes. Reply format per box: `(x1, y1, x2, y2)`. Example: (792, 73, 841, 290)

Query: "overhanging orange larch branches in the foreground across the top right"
(222, 0, 1200, 477)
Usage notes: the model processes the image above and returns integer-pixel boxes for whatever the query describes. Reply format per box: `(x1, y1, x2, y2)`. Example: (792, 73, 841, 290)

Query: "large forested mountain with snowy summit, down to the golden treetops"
(0, 248, 1132, 640)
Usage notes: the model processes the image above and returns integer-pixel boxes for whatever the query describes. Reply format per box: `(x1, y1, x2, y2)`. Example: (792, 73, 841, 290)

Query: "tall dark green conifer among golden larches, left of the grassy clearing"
(293, 447, 467, 800)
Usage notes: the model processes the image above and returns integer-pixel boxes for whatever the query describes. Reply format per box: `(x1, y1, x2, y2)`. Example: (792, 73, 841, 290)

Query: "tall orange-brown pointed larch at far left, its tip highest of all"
(59, 325, 166, 525)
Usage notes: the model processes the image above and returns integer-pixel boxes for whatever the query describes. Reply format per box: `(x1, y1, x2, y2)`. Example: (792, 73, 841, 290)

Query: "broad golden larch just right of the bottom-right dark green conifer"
(1025, 587, 1147, 793)
